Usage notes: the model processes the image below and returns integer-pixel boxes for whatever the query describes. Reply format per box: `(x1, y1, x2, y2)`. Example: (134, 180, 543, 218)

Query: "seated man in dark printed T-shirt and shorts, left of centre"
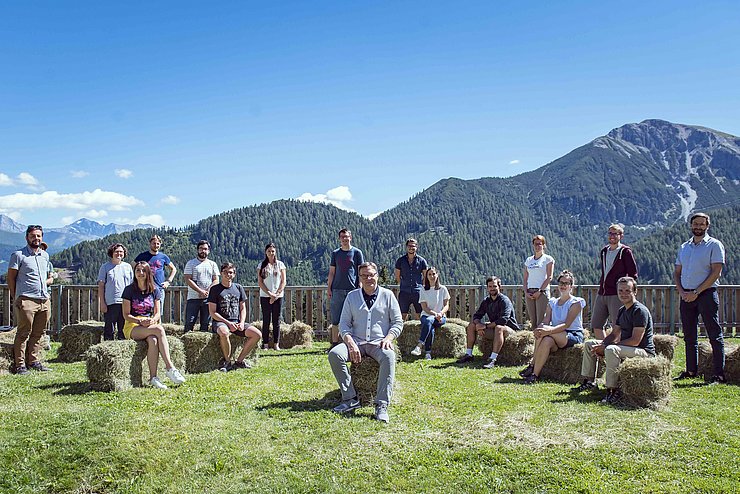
(208, 262, 262, 372)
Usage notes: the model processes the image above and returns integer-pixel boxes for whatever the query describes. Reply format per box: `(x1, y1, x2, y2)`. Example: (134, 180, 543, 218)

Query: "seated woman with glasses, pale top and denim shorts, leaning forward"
(519, 270, 586, 384)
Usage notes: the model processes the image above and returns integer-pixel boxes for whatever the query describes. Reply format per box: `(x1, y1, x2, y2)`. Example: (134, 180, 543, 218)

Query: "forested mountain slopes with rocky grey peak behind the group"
(47, 120, 740, 284)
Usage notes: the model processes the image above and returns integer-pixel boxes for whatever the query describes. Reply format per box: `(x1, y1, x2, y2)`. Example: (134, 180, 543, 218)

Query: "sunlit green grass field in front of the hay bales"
(0, 344, 740, 493)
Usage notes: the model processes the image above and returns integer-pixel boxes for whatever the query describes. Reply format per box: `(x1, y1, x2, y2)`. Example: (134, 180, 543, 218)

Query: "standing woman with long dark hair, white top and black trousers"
(257, 242, 285, 350)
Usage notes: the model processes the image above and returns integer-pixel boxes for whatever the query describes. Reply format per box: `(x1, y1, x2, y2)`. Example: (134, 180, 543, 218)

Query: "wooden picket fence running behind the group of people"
(0, 285, 740, 336)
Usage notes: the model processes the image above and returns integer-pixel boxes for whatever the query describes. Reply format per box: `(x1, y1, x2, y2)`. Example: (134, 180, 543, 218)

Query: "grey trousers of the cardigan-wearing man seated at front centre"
(329, 343, 396, 405)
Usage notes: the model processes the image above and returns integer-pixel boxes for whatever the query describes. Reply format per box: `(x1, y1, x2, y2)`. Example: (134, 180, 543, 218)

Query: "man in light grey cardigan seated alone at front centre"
(329, 262, 403, 423)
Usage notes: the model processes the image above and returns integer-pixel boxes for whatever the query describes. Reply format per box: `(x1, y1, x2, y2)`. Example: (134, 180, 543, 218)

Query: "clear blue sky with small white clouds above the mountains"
(0, 1, 740, 227)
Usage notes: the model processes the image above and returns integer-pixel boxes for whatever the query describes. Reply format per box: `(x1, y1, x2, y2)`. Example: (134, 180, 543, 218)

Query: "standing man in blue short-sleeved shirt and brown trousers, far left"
(7, 225, 54, 375)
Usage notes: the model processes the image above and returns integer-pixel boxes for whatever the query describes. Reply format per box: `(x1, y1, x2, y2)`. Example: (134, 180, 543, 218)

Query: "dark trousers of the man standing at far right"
(681, 288, 725, 376)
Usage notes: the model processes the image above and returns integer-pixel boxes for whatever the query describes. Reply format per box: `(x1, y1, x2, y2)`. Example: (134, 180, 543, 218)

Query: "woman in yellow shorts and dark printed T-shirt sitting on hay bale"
(123, 261, 185, 389)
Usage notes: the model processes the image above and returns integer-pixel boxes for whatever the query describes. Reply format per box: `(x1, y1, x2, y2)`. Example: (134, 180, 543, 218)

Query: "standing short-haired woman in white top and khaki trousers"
(523, 235, 555, 329)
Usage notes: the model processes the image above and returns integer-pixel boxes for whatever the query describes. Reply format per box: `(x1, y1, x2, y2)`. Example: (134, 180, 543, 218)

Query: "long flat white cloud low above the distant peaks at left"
(0, 189, 144, 212)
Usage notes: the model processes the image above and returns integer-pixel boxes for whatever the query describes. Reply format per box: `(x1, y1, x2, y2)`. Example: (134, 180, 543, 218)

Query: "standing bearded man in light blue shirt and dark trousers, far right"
(673, 213, 726, 383)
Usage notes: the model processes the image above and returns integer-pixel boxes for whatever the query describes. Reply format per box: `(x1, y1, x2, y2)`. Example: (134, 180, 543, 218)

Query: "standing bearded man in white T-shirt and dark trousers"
(183, 240, 219, 332)
